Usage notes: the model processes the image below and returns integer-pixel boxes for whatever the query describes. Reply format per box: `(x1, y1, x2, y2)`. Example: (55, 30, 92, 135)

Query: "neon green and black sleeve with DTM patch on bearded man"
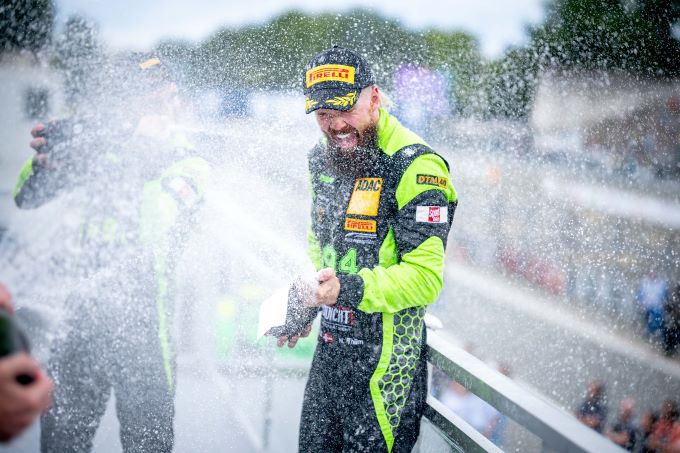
(339, 154, 458, 313)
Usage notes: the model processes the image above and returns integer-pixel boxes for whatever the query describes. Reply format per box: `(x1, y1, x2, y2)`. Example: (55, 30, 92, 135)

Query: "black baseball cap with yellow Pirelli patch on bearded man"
(302, 46, 375, 113)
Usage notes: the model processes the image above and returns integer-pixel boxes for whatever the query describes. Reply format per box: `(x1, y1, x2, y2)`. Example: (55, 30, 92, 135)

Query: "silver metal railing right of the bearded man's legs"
(425, 329, 624, 453)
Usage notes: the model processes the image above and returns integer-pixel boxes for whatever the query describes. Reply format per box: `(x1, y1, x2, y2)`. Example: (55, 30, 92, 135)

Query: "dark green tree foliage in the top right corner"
(483, 0, 680, 117)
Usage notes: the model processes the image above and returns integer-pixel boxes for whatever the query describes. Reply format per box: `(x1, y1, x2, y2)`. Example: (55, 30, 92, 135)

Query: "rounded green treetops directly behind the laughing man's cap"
(190, 10, 481, 106)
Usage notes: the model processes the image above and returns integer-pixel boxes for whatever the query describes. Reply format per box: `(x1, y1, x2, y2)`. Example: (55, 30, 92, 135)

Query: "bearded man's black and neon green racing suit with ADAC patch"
(299, 109, 458, 452)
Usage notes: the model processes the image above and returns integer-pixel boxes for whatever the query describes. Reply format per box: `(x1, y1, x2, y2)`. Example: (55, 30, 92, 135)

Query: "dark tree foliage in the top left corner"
(0, 0, 54, 53)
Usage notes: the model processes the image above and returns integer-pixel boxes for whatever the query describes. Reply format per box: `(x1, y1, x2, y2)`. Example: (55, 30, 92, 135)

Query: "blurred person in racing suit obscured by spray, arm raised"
(14, 58, 209, 452)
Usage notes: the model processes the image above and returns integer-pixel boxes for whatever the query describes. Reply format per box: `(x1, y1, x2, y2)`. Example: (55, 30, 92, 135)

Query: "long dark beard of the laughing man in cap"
(326, 126, 378, 176)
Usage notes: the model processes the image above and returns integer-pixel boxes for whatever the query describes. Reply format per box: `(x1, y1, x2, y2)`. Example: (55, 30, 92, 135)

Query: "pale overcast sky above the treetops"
(56, 0, 545, 57)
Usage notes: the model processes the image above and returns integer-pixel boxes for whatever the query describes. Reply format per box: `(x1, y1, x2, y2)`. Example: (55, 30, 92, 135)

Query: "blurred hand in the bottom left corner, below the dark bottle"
(0, 352, 54, 442)
